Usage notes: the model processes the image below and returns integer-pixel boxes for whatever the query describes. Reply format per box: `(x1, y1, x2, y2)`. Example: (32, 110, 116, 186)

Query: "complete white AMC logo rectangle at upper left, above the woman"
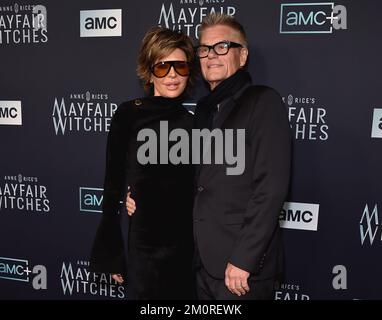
(80, 9, 122, 37)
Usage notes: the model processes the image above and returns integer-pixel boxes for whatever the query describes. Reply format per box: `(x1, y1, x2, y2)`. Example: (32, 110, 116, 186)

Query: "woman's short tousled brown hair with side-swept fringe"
(137, 27, 195, 91)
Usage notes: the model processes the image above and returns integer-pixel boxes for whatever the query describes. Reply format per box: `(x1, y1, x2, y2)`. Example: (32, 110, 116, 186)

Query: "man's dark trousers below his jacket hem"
(195, 252, 278, 300)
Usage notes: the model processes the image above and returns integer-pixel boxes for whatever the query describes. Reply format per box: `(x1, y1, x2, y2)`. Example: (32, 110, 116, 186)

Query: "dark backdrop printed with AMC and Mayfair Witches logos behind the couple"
(0, 0, 382, 300)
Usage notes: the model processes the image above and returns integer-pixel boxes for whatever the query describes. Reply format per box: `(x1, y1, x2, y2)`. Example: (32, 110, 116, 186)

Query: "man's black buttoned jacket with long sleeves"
(193, 85, 291, 279)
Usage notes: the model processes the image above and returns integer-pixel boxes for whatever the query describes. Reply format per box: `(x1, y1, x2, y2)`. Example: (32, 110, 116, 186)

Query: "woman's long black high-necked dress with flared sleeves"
(90, 97, 194, 299)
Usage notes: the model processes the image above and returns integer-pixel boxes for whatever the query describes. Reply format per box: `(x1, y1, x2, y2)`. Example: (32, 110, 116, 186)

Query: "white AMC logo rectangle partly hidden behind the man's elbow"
(279, 202, 320, 231)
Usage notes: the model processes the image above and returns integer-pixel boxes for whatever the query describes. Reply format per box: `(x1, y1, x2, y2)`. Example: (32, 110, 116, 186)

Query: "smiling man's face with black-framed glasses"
(200, 25, 248, 90)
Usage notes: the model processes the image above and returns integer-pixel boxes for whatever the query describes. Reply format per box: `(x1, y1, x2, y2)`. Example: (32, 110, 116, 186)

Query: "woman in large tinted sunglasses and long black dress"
(91, 27, 193, 299)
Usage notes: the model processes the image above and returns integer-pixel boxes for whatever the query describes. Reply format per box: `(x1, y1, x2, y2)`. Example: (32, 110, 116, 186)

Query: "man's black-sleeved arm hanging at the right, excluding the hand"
(229, 88, 291, 273)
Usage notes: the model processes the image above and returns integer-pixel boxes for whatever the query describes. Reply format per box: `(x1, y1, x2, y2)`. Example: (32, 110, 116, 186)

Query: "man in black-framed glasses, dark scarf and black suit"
(127, 14, 291, 299)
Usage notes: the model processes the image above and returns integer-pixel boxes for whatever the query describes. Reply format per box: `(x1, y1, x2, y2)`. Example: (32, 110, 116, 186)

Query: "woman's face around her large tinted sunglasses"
(151, 49, 189, 98)
